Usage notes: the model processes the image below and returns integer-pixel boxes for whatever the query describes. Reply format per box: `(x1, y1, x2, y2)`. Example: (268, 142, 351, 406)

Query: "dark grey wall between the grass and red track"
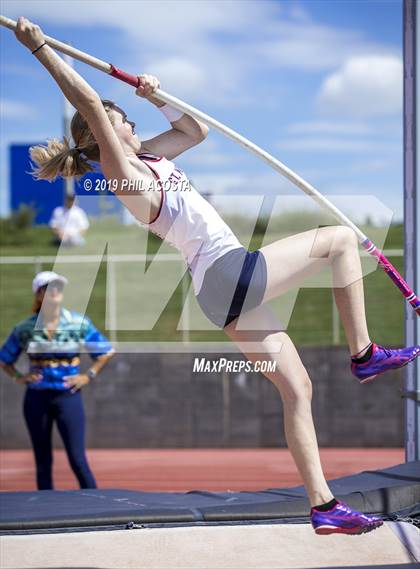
(0, 347, 404, 449)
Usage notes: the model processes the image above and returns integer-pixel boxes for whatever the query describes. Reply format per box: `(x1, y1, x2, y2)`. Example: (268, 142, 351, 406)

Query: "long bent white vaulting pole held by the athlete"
(0, 16, 420, 316)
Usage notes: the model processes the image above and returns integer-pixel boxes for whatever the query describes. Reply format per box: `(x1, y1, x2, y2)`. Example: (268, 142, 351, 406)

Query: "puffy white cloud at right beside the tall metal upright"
(317, 55, 403, 117)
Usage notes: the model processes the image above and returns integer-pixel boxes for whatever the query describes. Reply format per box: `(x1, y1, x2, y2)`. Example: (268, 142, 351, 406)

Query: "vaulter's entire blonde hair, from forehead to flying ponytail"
(29, 99, 116, 182)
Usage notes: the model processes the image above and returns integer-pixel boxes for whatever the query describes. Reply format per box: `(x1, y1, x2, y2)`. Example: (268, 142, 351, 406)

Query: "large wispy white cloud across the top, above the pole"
(2, 0, 400, 106)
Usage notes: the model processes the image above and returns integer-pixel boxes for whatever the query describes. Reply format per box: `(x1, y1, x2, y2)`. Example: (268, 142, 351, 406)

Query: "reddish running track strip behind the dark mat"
(0, 448, 405, 492)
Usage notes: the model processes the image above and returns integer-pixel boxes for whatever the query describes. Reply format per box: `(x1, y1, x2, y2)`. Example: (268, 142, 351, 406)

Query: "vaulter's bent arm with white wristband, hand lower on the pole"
(136, 75, 209, 160)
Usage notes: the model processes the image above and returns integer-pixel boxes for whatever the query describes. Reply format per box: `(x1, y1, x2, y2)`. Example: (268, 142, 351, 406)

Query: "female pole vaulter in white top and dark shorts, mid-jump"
(16, 18, 420, 534)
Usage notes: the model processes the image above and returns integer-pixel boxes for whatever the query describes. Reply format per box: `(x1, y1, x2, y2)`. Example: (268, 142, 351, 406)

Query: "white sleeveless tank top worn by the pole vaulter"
(138, 153, 243, 295)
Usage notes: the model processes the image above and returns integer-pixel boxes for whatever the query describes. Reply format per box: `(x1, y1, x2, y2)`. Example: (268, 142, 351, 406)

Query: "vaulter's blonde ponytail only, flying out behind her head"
(29, 137, 93, 182)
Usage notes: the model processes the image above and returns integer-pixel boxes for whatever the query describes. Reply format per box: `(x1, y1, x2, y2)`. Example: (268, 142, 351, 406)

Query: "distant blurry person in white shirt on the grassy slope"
(49, 195, 89, 247)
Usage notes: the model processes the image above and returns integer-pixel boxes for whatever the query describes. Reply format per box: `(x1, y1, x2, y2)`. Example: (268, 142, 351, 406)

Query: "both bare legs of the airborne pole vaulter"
(224, 226, 370, 506)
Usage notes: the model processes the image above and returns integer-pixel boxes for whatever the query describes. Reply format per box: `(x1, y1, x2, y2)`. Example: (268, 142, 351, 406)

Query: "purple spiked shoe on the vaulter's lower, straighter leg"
(311, 500, 383, 535)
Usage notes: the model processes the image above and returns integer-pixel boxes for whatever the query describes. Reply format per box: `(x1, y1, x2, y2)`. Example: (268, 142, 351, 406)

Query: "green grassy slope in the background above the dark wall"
(0, 215, 404, 345)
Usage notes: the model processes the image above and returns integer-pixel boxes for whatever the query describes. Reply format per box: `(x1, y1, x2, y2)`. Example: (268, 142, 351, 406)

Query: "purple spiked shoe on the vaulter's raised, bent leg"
(351, 344, 420, 383)
